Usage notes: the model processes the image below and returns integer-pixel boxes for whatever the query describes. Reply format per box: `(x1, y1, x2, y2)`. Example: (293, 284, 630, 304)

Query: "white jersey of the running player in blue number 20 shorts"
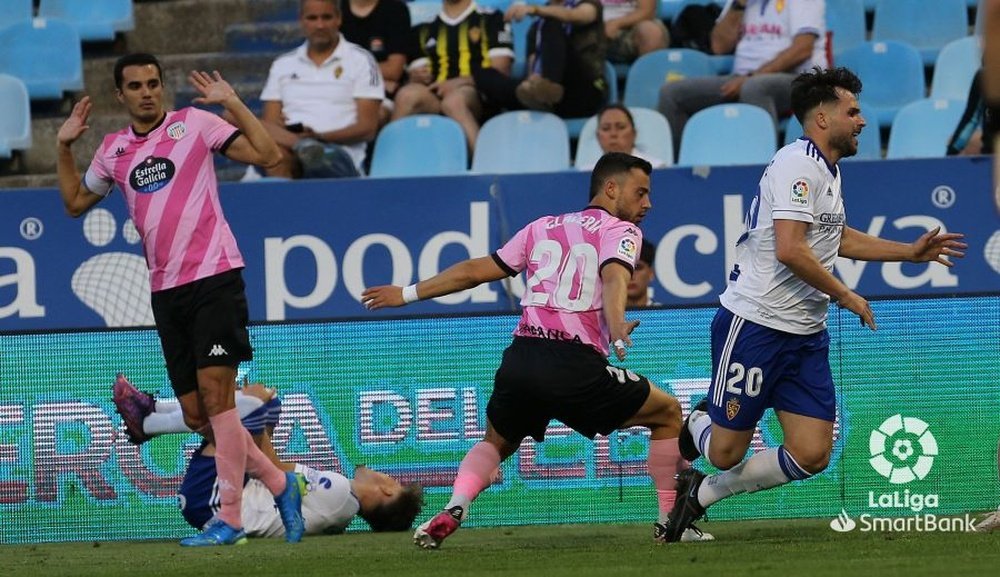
(719, 138, 845, 335)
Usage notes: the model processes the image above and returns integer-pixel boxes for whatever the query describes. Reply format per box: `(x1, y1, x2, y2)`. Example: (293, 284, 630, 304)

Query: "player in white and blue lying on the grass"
(114, 375, 423, 542)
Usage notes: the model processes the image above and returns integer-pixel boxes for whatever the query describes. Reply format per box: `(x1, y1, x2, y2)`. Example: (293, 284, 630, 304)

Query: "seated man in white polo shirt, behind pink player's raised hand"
(260, 0, 385, 178)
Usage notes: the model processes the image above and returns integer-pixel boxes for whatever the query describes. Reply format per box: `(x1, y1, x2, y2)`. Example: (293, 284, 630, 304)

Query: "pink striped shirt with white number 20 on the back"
(493, 207, 642, 356)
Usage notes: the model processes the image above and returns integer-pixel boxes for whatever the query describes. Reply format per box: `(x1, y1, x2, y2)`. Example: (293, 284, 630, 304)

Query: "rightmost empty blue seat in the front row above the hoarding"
(885, 98, 965, 158)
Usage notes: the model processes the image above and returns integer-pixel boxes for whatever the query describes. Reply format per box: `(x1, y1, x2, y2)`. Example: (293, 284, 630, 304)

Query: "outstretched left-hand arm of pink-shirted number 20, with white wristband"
(361, 256, 507, 310)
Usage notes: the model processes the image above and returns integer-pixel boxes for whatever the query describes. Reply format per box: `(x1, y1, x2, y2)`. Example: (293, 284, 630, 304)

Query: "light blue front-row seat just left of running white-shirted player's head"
(677, 104, 778, 166)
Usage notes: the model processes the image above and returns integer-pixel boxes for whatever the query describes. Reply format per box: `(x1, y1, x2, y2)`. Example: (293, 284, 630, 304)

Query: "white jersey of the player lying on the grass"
(242, 465, 361, 537)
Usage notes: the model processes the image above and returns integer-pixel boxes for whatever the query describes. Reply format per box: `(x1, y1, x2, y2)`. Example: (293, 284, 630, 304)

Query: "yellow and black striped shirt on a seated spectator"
(409, 3, 514, 82)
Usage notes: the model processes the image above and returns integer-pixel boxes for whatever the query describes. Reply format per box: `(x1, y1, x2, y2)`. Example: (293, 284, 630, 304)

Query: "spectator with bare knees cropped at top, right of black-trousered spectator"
(601, 0, 670, 64)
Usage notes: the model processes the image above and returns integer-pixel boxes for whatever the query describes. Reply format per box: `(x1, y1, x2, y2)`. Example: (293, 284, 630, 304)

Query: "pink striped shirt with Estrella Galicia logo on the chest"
(84, 108, 244, 292)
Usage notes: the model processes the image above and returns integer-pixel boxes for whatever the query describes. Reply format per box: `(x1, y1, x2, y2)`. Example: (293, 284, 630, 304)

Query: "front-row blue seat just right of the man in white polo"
(369, 114, 469, 177)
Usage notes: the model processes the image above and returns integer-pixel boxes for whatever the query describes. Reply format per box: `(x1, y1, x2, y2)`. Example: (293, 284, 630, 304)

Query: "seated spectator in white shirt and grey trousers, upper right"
(659, 0, 828, 153)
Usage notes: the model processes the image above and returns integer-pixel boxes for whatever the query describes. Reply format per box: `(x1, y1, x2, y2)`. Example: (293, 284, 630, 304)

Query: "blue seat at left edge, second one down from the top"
(0, 18, 83, 100)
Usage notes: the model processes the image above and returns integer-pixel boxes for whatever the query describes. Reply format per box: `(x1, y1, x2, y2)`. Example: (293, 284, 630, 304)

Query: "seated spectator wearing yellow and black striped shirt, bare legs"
(392, 0, 514, 151)
